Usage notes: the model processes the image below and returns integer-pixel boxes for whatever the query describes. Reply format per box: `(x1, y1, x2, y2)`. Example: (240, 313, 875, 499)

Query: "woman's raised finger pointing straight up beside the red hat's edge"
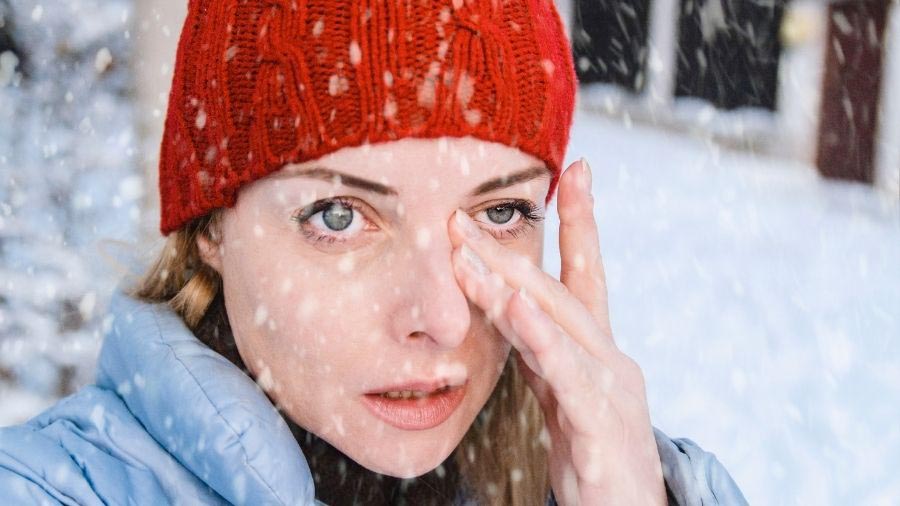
(556, 158, 612, 336)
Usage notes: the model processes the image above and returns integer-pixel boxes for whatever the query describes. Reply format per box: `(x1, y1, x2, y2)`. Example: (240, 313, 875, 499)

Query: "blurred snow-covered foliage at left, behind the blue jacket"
(0, 0, 145, 425)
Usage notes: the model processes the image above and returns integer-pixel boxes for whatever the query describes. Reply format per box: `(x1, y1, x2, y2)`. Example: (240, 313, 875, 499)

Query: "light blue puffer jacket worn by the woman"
(0, 291, 746, 506)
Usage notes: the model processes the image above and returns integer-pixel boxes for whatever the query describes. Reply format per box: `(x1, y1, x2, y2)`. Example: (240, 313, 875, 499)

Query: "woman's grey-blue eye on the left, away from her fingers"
(293, 197, 368, 244)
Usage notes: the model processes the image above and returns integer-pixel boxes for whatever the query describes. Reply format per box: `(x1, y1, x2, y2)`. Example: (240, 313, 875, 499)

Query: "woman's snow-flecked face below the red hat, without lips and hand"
(200, 137, 550, 477)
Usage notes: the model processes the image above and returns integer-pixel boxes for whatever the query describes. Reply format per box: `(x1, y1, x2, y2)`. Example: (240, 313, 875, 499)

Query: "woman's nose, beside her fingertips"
(394, 231, 471, 348)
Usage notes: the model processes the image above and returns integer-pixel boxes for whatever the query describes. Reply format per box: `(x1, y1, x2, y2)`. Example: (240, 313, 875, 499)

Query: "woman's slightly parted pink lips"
(362, 382, 468, 430)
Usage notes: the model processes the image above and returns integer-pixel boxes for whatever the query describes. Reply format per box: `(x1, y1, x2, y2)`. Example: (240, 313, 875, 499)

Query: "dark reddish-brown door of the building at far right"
(816, 0, 889, 183)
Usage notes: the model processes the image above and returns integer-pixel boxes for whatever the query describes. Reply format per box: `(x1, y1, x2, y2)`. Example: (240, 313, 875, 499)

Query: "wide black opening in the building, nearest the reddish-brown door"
(675, 0, 787, 111)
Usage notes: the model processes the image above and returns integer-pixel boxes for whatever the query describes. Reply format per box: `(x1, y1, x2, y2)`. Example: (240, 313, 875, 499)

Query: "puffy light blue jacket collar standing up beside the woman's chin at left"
(97, 284, 315, 504)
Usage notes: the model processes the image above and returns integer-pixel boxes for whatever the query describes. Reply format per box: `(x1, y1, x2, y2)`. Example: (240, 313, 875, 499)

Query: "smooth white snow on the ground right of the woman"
(544, 108, 900, 505)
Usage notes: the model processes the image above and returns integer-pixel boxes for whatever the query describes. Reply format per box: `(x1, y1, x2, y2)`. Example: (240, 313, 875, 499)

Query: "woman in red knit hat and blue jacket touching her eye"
(0, 0, 745, 505)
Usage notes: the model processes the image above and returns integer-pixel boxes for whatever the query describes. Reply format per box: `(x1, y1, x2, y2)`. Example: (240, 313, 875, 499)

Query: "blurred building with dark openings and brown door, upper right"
(561, 0, 900, 198)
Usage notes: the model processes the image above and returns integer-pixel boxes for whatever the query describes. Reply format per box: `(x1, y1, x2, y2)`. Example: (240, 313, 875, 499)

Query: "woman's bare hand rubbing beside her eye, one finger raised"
(451, 160, 666, 506)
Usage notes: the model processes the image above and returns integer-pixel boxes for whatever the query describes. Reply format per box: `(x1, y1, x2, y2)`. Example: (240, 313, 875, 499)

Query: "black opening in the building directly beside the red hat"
(572, 0, 650, 92)
